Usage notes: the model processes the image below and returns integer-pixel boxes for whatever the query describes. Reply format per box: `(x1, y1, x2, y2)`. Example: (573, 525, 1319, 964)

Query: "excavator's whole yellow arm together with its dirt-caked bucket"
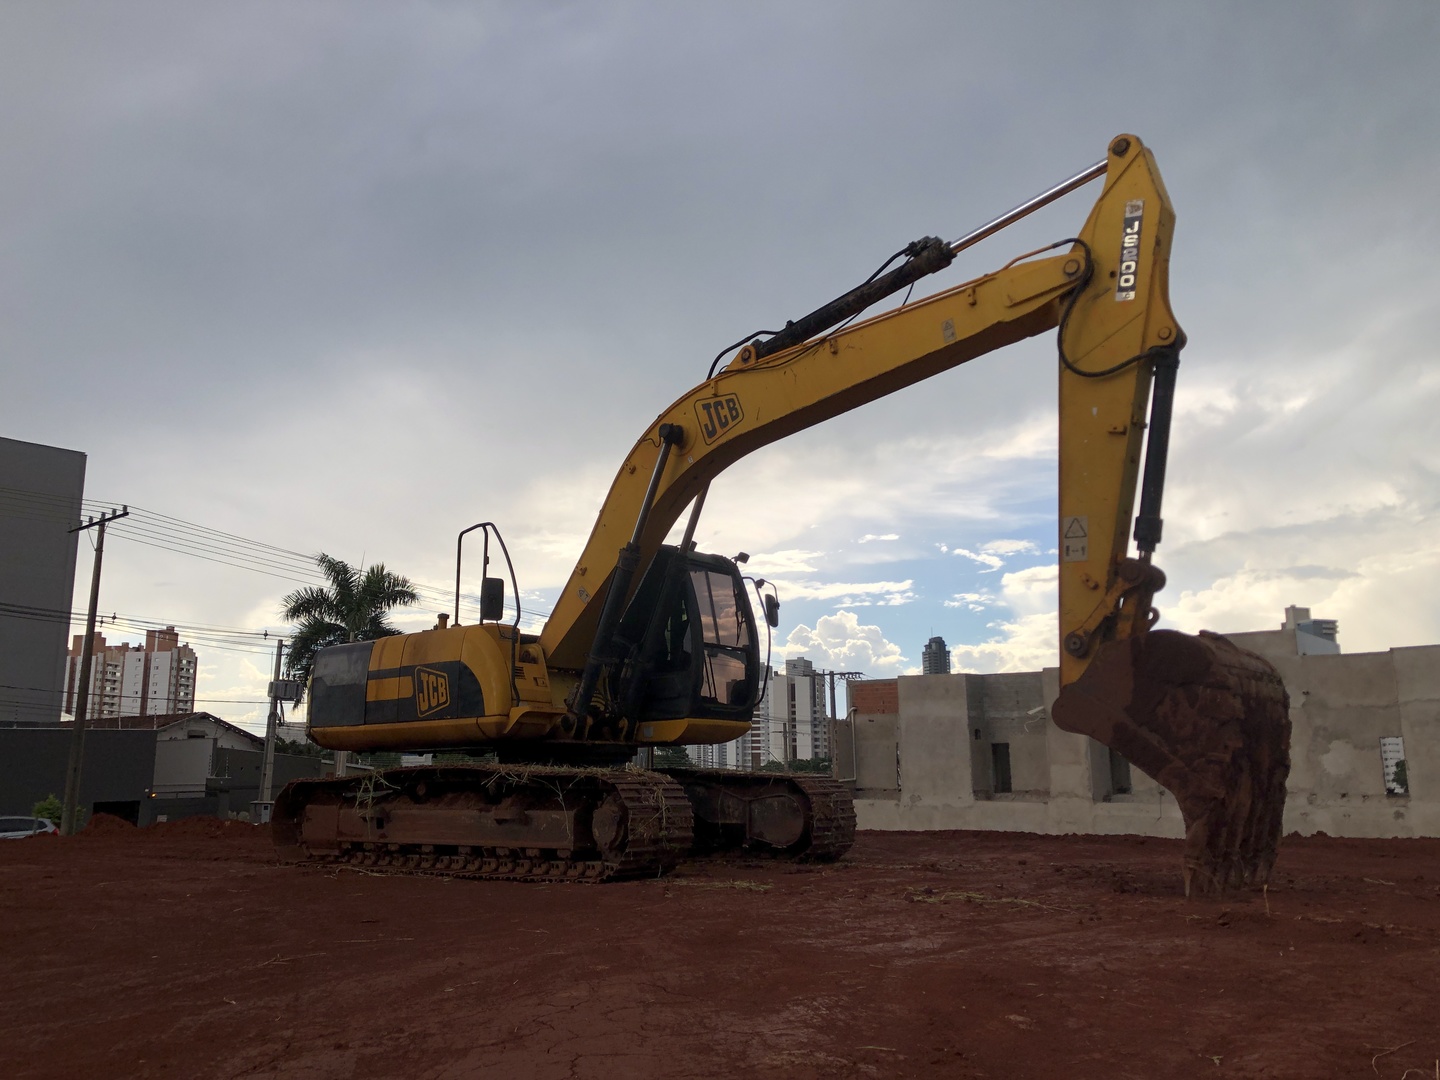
(540, 135, 1289, 891)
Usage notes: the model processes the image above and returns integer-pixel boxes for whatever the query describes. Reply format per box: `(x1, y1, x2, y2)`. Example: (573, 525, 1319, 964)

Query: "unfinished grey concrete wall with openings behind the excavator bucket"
(837, 642, 1440, 837)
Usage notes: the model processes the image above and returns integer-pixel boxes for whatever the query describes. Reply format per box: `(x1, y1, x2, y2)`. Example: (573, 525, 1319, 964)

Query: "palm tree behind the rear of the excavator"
(281, 553, 419, 683)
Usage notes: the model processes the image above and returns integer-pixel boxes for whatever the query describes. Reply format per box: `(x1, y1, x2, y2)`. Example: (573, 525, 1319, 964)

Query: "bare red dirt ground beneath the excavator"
(0, 821, 1440, 1080)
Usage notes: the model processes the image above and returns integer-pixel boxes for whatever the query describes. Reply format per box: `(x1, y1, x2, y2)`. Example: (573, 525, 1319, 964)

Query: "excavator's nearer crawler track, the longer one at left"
(271, 765, 694, 881)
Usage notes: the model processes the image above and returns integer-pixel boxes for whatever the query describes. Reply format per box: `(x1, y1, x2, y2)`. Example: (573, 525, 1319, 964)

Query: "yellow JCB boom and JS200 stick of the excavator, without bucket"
(540, 135, 1184, 694)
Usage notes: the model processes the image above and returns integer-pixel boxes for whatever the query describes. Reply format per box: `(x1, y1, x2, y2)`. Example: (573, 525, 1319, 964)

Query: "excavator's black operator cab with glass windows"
(615, 546, 760, 721)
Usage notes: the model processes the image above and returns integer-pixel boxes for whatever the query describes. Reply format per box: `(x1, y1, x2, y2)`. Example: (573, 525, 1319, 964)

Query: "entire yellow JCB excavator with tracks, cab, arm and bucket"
(272, 135, 1289, 893)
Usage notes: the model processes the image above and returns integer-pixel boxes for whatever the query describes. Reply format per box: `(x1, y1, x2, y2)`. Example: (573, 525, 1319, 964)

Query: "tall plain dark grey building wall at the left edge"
(0, 438, 89, 724)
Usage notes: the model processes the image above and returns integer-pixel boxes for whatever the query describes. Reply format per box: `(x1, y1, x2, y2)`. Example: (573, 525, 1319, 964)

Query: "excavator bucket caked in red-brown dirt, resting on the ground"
(1053, 631, 1290, 896)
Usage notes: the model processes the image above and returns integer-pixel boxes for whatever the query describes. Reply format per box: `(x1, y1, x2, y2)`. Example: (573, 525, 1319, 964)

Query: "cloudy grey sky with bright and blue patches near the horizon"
(0, 0, 1440, 723)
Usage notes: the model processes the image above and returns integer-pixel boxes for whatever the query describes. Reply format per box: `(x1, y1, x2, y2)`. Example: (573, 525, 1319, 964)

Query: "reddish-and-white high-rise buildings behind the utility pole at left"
(65, 626, 197, 717)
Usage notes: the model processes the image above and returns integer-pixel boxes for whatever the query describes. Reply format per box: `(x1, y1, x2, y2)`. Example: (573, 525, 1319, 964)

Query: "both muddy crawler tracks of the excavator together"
(271, 765, 855, 881)
